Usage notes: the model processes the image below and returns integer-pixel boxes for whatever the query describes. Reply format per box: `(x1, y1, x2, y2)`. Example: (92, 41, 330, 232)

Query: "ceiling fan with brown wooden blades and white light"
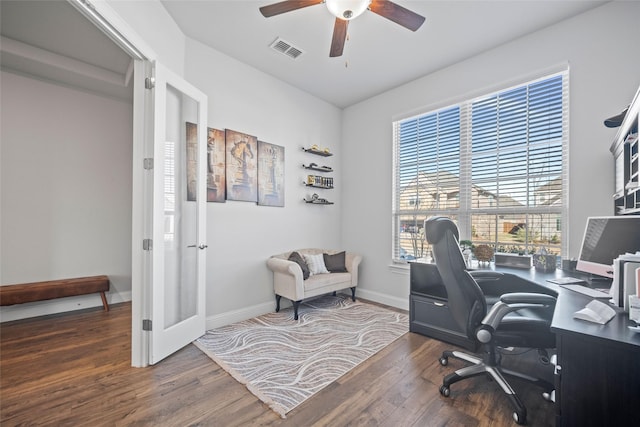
(260, 0, 425, 57)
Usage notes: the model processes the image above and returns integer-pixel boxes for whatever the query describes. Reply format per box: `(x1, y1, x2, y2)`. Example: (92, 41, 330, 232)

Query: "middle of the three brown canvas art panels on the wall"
(225, 129, 258, 202)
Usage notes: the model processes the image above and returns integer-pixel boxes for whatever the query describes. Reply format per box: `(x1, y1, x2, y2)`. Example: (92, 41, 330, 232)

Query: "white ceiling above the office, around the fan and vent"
(162, 0, 606, 107)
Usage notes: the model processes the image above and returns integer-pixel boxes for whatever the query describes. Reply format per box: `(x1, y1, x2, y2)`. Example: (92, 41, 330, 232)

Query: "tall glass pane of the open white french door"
(164, 85, 198, 329)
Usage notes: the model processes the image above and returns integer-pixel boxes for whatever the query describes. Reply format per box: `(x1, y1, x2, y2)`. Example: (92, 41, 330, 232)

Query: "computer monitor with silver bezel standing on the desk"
(576, 215, 640, 278)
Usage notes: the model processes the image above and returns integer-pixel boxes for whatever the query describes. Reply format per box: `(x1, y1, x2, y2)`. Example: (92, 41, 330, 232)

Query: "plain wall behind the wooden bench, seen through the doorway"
(0, 71, 132, 321)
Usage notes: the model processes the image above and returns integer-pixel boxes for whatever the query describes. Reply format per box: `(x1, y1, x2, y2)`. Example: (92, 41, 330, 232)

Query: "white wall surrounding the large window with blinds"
(342, 2, 640, 308)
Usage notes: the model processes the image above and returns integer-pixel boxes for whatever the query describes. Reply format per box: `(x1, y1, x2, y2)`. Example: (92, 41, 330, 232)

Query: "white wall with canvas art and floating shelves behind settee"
(185, 39, 344, 325)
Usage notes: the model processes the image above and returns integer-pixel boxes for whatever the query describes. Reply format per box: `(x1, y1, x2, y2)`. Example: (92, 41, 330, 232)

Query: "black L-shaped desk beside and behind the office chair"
(410, 265, 640, 427)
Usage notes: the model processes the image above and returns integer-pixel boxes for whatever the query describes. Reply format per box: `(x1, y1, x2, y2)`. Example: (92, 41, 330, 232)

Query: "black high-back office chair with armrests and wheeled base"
(425, 217, 556, 424)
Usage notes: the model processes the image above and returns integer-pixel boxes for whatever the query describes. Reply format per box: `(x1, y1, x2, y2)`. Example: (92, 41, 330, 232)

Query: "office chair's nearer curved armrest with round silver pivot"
(476, 292, 556, 344)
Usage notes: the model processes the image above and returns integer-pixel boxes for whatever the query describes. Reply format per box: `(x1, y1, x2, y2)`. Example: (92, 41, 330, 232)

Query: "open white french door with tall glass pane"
(144, 63, 207, 364)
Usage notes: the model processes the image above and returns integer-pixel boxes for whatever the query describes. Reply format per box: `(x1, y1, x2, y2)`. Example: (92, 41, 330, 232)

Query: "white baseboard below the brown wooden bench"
(0, 291, 131, 322)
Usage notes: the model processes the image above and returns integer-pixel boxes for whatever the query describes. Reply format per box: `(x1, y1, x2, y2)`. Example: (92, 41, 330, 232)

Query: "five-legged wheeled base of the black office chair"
(439, 351, 553, 424)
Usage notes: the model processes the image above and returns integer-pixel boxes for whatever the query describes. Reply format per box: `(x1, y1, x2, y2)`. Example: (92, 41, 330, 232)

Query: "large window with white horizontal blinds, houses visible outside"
(393, 71, 569, 260)
